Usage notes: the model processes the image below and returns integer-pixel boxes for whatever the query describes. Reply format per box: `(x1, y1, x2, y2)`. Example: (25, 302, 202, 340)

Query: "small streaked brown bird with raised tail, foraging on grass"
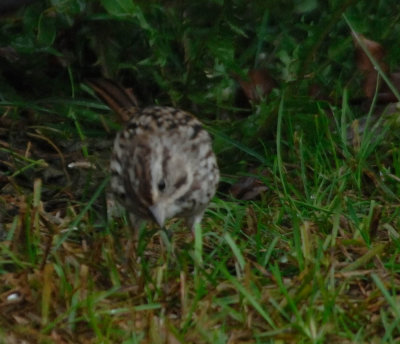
(87, 79, 219, 234)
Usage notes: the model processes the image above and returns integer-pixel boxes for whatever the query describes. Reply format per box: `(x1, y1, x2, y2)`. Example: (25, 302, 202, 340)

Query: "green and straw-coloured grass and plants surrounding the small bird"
(0, 0, 400, 344)
